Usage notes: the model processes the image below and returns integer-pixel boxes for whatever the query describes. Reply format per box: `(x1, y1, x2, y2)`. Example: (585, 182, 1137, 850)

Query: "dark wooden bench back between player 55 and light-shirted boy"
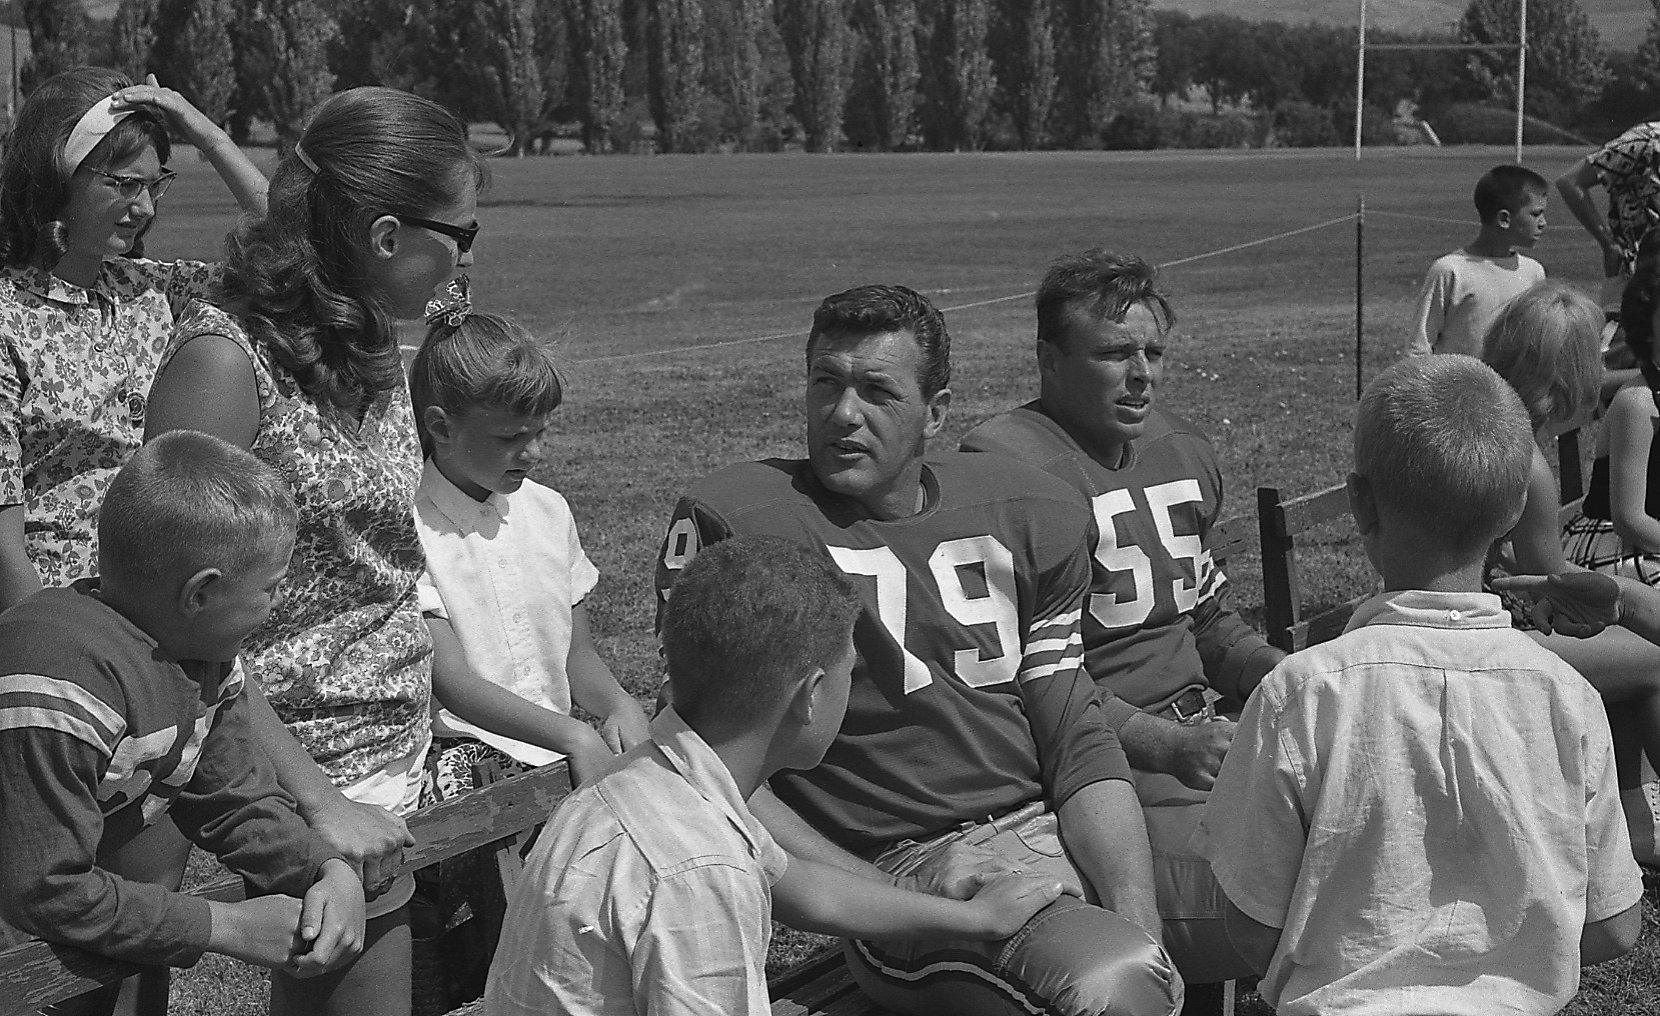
(1257, 423, 1585, 652)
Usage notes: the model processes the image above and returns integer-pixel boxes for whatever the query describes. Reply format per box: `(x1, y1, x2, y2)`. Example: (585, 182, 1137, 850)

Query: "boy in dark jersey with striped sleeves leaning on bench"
(0, 430, 364, 996)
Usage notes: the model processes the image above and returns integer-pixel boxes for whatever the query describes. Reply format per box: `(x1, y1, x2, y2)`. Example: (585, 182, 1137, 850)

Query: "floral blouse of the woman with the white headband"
(0, 257, 219, 586)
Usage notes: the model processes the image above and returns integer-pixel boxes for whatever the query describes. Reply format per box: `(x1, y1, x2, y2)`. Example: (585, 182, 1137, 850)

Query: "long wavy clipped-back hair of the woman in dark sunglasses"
(224, 88, 486, 407)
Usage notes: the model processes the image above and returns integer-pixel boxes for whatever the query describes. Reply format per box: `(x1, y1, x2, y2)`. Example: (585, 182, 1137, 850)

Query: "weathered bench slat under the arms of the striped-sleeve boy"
(0, 762, 571, 1016)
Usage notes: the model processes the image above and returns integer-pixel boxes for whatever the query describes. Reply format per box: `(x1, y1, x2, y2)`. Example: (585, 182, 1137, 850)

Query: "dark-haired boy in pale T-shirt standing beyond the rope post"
(1406, 164, 1550, 357)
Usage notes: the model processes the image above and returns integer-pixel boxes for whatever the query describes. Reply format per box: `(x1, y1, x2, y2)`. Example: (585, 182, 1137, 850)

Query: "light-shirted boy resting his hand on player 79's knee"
(485, 536, 1061, 1016)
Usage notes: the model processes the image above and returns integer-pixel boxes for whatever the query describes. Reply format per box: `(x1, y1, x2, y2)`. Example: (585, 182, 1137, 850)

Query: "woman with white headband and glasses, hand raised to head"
(0, 66, 266, 609)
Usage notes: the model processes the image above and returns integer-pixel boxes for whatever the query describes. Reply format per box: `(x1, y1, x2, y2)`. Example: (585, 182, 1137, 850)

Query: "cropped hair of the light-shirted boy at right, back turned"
(1355, 354, 1534, 554)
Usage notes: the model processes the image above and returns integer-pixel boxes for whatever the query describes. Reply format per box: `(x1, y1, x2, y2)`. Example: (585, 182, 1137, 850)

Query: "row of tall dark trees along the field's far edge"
(13, 0, 1660, 151)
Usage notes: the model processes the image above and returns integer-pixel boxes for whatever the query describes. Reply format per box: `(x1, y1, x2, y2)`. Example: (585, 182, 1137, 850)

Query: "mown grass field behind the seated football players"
(136, 149, 1660, 1016)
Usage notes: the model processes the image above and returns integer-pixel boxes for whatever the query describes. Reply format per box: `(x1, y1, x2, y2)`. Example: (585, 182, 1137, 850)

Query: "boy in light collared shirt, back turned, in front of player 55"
(1194, 355, 1642, 1016)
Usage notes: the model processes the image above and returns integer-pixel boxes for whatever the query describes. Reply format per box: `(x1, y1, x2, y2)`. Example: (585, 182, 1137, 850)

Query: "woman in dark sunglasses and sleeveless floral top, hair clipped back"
(146, 88, 483, 1016)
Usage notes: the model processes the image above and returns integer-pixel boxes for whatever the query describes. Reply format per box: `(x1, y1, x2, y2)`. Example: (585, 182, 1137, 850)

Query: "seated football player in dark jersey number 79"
(657, 286, 1182, 1016)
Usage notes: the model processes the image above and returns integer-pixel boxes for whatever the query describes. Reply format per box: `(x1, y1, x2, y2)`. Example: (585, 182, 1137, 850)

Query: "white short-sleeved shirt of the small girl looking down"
(415, 460, 599, 765)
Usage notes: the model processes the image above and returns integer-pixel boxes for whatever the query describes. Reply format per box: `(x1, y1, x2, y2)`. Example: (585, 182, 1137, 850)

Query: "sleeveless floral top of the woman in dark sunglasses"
(161, 302, 432, 785)
